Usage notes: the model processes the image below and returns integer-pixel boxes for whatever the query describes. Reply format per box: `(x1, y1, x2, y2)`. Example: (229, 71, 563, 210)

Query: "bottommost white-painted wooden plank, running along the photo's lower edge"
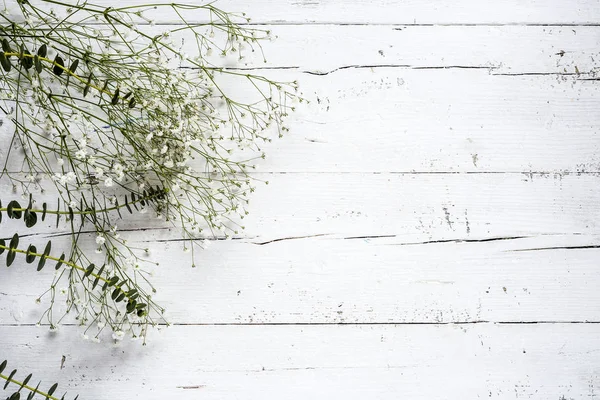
(0, 324, 600, 400)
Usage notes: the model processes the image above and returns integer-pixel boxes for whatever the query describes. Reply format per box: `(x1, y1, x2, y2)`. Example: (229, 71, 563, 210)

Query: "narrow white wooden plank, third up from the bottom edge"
(2, 173, 600, 242)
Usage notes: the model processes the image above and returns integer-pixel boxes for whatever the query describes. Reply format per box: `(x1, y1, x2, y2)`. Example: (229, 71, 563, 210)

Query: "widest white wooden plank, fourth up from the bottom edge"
(0, 68, 600, 173)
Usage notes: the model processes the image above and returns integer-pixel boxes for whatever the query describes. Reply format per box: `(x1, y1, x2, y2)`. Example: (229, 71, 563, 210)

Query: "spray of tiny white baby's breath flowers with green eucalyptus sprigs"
(0, 0, 302, 393)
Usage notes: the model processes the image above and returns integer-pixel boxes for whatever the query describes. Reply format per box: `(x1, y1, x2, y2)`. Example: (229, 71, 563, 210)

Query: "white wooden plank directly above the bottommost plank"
(0, 233, 600, 325)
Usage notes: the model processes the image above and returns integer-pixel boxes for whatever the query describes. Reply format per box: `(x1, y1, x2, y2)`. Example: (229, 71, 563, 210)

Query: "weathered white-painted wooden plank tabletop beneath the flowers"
(0, 0, 600, 400)
